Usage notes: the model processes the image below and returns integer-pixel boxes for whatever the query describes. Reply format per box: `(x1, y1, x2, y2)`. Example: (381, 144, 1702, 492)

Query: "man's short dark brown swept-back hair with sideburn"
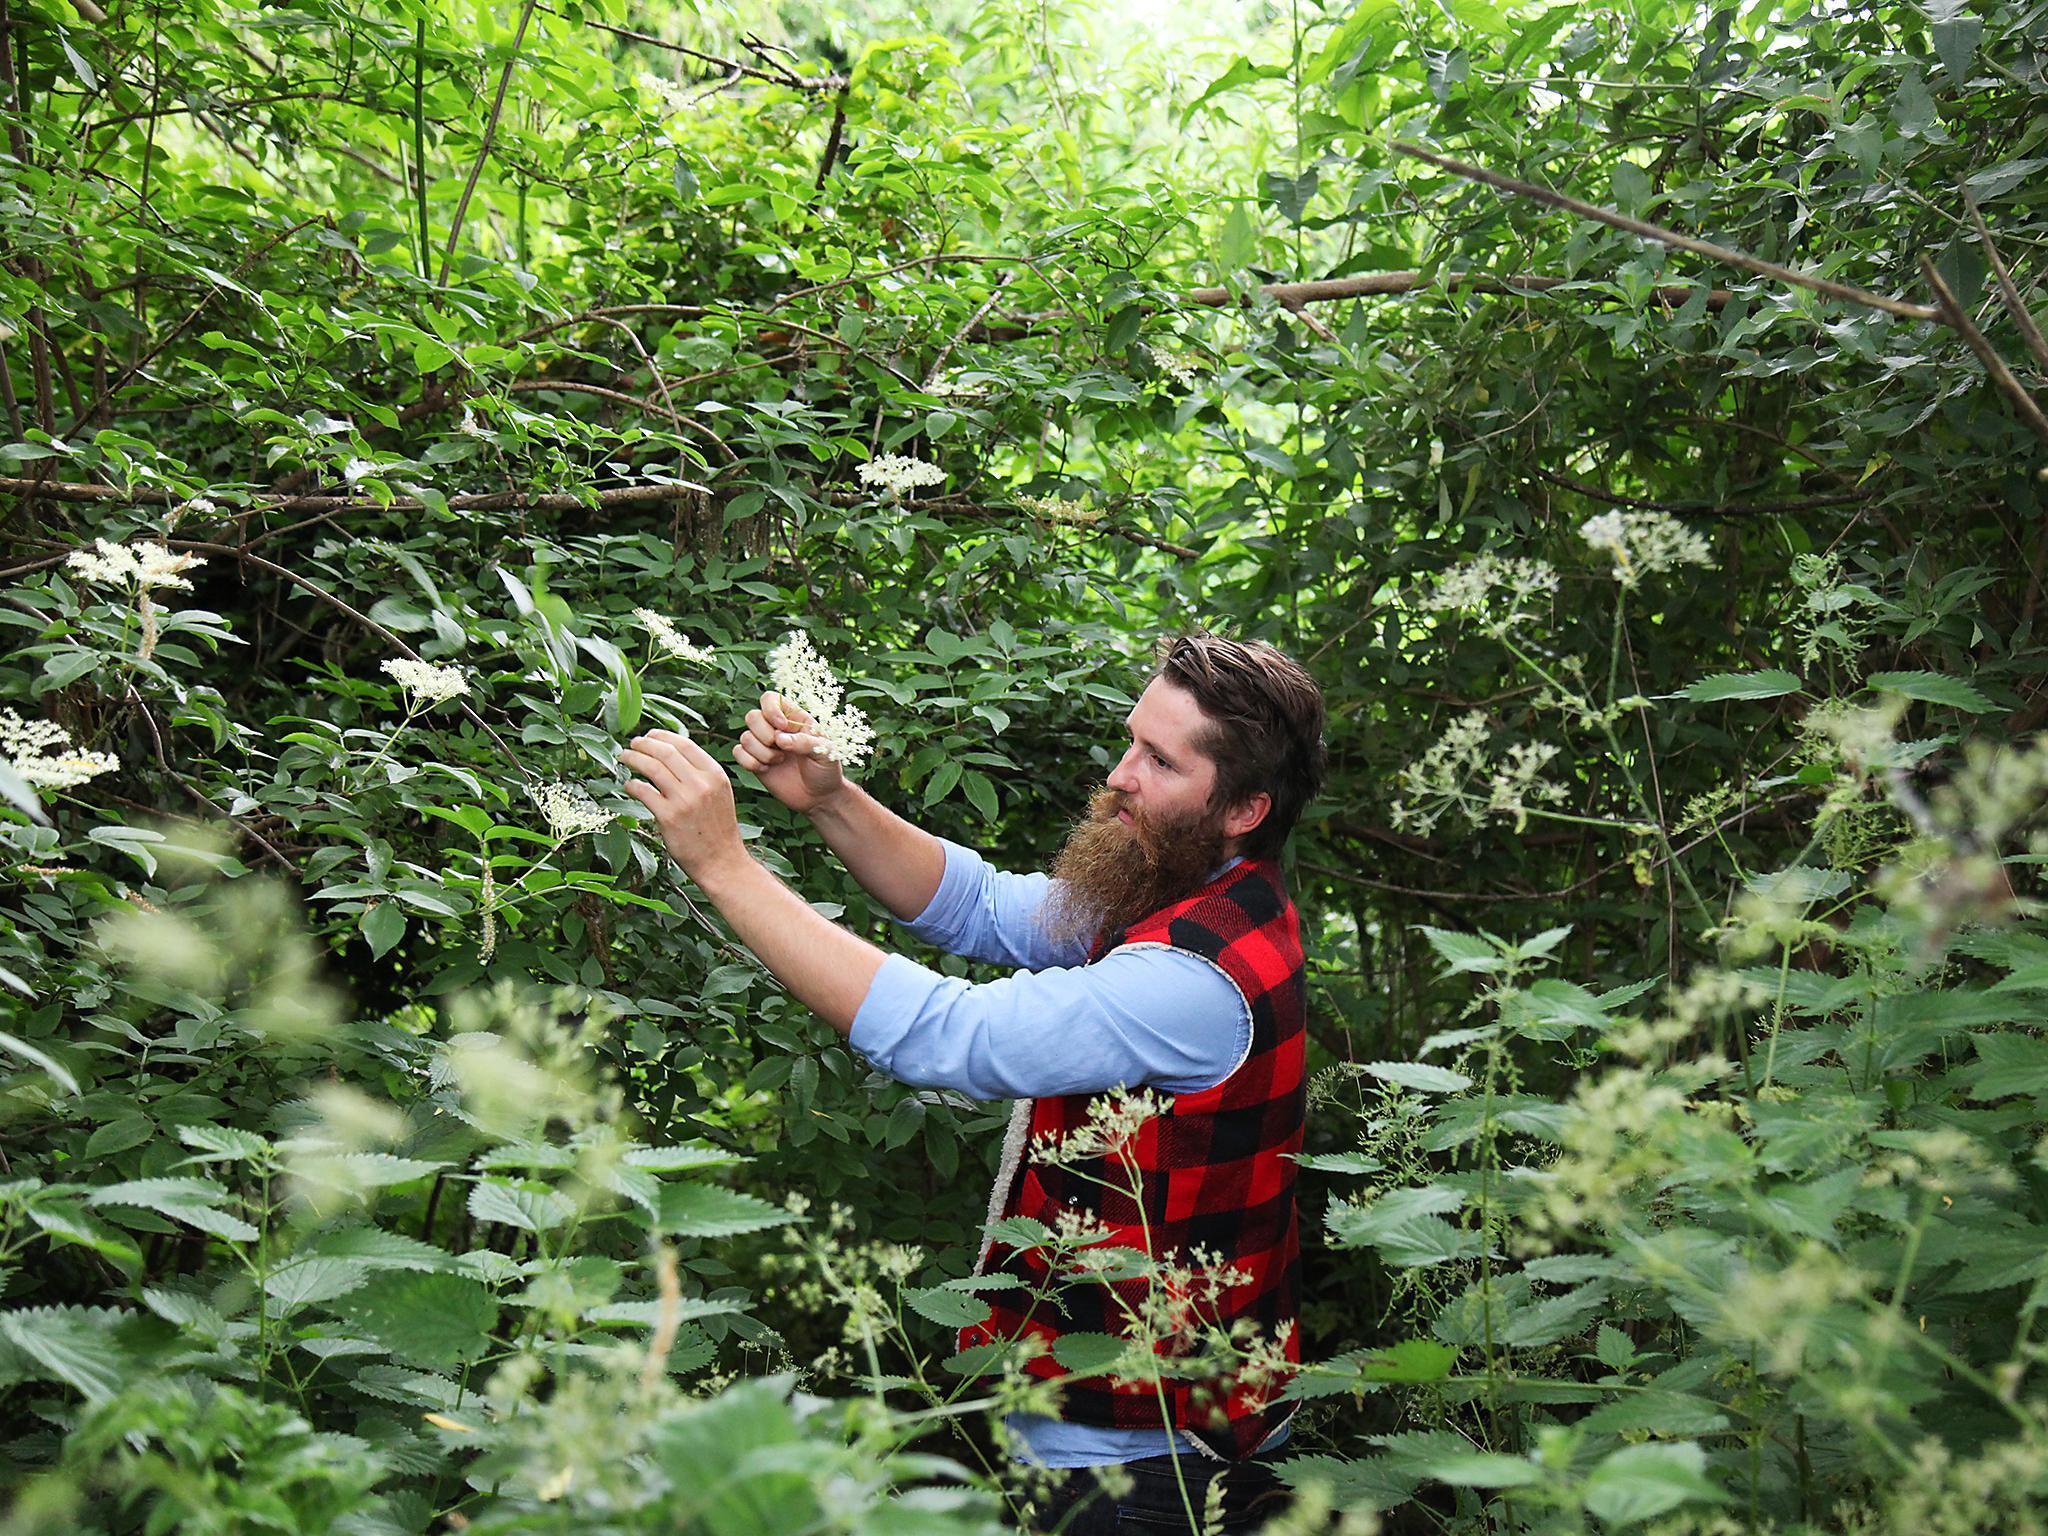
(1153, 631, 1327, 858)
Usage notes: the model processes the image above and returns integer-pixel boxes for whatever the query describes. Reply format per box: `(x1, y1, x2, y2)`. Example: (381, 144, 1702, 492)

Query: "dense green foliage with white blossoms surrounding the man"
(0, 0, 2048, 1536)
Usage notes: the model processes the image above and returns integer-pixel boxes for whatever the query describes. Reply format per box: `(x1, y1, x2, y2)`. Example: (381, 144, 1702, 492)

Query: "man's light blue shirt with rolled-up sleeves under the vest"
(848, 840, 1286, 1466)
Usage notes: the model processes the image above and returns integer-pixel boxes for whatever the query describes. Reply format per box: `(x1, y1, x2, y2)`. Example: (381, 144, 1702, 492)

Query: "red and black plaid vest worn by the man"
(961, 860, 1307, 1460)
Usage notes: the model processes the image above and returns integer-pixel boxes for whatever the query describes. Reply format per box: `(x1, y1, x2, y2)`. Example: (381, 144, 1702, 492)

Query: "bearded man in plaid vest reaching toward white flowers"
(621, 635, 1325, 1536)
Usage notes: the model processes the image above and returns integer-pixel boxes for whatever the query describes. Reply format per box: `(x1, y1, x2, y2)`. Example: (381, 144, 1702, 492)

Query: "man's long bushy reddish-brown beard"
(1042, 788, 1225, 940)
